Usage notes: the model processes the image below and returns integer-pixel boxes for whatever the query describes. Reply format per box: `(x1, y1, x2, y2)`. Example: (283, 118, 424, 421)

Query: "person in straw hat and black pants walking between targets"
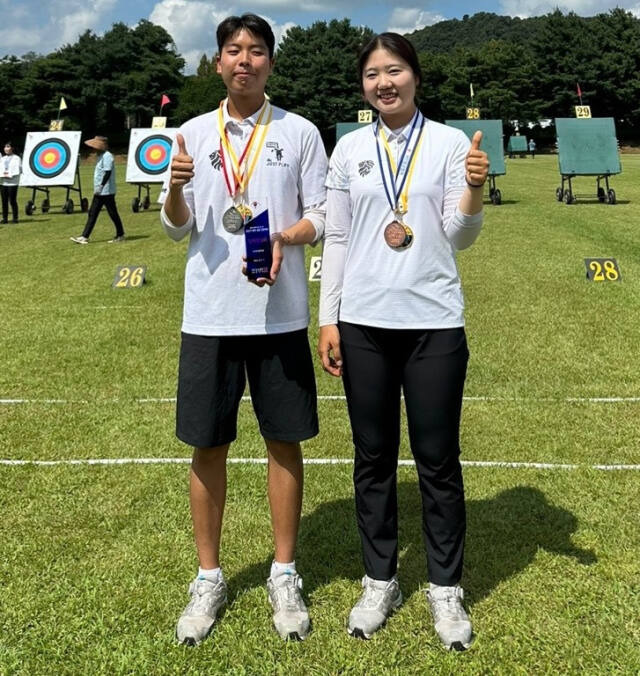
(71, 136, 124, 244)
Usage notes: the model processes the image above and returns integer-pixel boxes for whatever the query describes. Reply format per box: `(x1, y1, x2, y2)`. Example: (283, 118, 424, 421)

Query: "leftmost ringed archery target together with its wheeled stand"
(20, 131, 89, 216)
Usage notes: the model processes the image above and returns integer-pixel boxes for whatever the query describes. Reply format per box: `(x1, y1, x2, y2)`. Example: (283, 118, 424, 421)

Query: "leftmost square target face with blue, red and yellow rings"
(20, 131, 81, 186)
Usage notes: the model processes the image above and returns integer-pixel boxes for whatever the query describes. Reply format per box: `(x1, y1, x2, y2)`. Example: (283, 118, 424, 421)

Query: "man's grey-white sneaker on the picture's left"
(176, 576, 227, 646)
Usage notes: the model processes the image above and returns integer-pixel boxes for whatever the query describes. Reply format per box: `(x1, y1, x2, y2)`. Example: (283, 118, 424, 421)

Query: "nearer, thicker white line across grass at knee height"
(0, 458, 640, 472)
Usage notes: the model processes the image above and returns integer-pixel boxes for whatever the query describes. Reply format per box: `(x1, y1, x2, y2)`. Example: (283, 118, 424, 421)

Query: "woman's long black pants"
(340, 322, 469, 585)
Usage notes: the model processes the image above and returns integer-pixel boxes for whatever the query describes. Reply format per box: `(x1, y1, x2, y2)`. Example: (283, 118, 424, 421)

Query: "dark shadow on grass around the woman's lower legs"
(229, 482, 597, 604)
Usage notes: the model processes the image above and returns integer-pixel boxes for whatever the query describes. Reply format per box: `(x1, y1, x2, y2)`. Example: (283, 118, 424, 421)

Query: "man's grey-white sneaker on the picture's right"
(267, 573, 311, 641)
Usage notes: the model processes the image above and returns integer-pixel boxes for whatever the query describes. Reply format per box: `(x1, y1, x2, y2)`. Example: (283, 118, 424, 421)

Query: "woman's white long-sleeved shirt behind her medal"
(319, 120, 483, 329)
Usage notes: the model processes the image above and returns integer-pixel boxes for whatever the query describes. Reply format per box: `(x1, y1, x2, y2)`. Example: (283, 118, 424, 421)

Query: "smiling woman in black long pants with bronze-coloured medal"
(318, 33, 489, 650)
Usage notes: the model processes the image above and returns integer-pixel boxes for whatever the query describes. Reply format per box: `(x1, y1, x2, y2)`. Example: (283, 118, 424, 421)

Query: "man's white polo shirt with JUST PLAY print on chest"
(160, 103, 327, 336)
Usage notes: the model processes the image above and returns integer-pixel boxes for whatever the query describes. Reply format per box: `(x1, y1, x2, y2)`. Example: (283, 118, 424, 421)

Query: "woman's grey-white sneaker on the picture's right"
(427, 584, 473, 651)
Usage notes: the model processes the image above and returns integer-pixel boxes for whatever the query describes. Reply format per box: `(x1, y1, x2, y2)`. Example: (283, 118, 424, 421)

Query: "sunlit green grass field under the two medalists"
(0, 155, 640, 676)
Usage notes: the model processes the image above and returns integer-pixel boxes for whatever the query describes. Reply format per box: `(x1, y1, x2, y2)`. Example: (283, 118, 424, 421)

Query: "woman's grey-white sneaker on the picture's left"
(347, 575, 402, 639)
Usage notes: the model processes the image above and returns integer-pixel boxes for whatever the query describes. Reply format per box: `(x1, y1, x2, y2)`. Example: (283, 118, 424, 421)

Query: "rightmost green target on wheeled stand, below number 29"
(555, 117, 622, 204)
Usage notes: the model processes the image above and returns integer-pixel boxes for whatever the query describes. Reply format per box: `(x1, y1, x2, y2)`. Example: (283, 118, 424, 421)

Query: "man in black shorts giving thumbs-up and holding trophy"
(161, 14, 327, 645)
